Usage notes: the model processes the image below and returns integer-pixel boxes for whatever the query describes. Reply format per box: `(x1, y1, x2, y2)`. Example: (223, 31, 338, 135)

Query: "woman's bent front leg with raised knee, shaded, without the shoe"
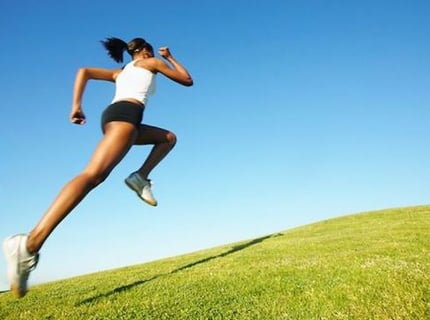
(134, 124, 176, 180)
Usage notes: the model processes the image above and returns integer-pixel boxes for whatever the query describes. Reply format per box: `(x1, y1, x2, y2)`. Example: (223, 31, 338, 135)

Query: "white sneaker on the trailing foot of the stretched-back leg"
(3, 234, 39, 298)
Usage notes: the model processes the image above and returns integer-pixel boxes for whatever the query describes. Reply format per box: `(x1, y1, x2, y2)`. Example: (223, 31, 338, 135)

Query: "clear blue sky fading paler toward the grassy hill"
(0, 0, 430, 290)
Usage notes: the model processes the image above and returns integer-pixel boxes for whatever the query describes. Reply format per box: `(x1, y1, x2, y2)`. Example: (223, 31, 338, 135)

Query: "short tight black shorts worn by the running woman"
(101, 101, 144, 132)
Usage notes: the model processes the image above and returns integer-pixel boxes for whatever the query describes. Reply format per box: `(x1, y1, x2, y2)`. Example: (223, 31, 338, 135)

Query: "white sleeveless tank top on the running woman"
(112, 61, 155, 105)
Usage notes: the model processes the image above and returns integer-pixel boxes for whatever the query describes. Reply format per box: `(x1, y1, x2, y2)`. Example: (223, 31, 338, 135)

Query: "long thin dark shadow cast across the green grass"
(75, 233, 282, 306)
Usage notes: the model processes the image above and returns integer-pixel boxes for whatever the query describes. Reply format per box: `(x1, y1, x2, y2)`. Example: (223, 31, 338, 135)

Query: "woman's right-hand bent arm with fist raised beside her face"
(151, 47, 193, 87)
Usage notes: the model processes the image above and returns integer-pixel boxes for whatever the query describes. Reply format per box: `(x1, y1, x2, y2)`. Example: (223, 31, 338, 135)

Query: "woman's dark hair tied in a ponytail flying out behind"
(101, 38, 154, 62)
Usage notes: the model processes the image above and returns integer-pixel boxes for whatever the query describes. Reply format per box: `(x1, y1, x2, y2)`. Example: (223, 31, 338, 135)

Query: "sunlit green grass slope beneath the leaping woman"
(0, 206, 430, 320)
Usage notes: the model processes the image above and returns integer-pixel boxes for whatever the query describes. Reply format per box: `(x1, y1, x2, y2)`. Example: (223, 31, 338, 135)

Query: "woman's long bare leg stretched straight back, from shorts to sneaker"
(27, 122, 137, 253)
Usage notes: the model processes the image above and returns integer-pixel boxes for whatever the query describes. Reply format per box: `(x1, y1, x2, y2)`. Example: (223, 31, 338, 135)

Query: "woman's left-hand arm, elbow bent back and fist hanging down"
(70, 68, 121, 124)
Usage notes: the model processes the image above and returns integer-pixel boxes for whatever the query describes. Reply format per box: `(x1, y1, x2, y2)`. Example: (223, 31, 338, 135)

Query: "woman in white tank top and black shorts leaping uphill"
(3, 38, 193, 297)
